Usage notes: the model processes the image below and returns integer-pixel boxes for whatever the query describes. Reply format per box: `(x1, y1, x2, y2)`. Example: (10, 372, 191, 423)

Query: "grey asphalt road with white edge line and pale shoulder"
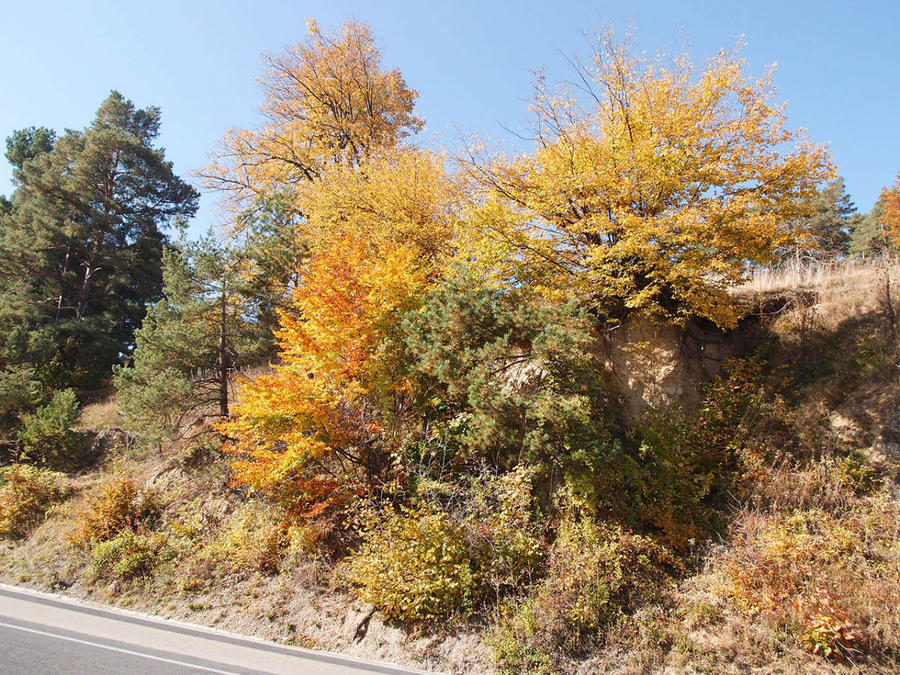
(0, 584, 428, 675)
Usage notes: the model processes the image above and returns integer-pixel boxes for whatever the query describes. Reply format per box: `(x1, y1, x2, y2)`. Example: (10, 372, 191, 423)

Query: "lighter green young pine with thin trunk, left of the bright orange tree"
(115, 234, 268, 441)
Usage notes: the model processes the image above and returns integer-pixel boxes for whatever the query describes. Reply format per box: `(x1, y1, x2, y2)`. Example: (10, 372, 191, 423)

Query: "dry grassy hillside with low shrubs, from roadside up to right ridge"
(0, 265, 900, 673)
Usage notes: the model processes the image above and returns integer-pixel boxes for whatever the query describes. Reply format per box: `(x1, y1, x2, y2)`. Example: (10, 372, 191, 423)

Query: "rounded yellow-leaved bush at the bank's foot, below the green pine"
(343, 506, 477, 621)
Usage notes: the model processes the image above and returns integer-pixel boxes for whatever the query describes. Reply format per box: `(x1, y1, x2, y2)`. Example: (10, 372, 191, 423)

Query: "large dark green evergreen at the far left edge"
(0, 92, 198, 388)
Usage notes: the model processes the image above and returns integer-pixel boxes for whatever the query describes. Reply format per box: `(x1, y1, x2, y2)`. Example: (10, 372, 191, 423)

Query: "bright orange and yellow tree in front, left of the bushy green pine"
(220, 235, 427, 513)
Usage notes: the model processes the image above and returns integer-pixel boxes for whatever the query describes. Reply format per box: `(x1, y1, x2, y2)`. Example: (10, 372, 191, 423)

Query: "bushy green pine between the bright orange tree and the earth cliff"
(401, 269, 605, 477)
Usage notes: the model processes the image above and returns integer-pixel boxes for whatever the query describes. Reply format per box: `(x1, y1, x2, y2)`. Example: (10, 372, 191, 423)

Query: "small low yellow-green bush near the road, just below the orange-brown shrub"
(91, 530, 175, 579)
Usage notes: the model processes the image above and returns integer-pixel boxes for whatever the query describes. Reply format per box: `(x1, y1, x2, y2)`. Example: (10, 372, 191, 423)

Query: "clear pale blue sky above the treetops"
(0, 0, 900, 231)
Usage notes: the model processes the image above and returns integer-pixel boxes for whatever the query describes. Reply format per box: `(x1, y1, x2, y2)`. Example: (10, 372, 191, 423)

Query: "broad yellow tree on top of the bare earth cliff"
(464, 34, 833, 326)
